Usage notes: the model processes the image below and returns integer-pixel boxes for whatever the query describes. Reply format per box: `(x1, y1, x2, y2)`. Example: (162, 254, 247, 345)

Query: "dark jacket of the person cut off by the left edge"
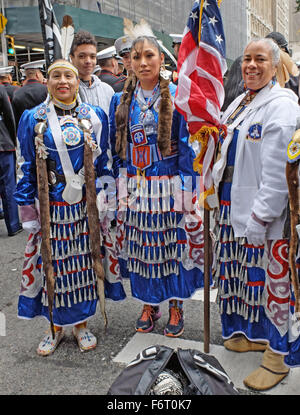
(0, 85, 17, 151)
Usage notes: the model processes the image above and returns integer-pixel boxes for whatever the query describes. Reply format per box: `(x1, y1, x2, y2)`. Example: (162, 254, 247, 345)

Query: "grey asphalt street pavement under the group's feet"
(0, 220, 300, 395)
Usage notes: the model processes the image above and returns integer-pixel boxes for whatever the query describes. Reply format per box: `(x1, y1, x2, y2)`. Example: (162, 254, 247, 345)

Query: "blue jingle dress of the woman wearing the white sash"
(15, 103, 125, 326)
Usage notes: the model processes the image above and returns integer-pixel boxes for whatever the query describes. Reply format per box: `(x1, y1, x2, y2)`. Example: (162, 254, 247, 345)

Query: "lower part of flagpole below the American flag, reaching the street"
(204, 209, 211, 353)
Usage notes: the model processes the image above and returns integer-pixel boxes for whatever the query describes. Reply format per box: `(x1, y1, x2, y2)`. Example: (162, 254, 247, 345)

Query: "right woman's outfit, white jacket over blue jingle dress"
(213, 82, 300, 366)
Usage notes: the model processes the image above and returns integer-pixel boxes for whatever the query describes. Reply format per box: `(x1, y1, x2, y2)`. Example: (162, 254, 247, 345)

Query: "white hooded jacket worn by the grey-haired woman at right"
(213, 83, 300, 239)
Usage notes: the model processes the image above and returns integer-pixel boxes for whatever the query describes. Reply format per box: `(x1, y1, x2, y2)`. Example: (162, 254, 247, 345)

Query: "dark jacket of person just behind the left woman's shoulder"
(12, 79, 48, 126)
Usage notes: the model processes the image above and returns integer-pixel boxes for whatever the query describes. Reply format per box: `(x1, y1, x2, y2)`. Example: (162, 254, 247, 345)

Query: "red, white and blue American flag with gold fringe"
(175, 0, 227, 209)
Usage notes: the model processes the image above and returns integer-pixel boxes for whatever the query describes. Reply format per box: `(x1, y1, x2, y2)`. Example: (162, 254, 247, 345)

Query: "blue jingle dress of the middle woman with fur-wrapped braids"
(110, 83, 204, 305)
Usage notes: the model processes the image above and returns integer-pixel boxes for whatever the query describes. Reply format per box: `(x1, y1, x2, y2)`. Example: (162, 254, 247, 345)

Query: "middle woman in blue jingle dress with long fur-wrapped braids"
(110, 31, 204, 337)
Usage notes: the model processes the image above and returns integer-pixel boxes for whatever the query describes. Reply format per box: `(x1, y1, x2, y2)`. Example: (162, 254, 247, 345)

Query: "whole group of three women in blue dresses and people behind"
(0, 22, 300, 390)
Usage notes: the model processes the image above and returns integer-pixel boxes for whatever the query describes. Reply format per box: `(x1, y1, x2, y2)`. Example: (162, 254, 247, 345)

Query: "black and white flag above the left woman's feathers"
(39, 0, 62, 68)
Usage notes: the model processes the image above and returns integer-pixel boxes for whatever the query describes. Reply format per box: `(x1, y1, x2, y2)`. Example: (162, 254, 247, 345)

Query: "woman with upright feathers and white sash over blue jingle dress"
(15, 60, 125, 356)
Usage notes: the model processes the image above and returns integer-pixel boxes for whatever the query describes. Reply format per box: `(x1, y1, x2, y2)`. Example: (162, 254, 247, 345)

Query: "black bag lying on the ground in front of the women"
(107, 345, 239, 395)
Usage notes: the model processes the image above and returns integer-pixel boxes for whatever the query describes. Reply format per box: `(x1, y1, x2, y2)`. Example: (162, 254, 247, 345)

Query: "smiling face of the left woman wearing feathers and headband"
(47, 68, 79, 104)
